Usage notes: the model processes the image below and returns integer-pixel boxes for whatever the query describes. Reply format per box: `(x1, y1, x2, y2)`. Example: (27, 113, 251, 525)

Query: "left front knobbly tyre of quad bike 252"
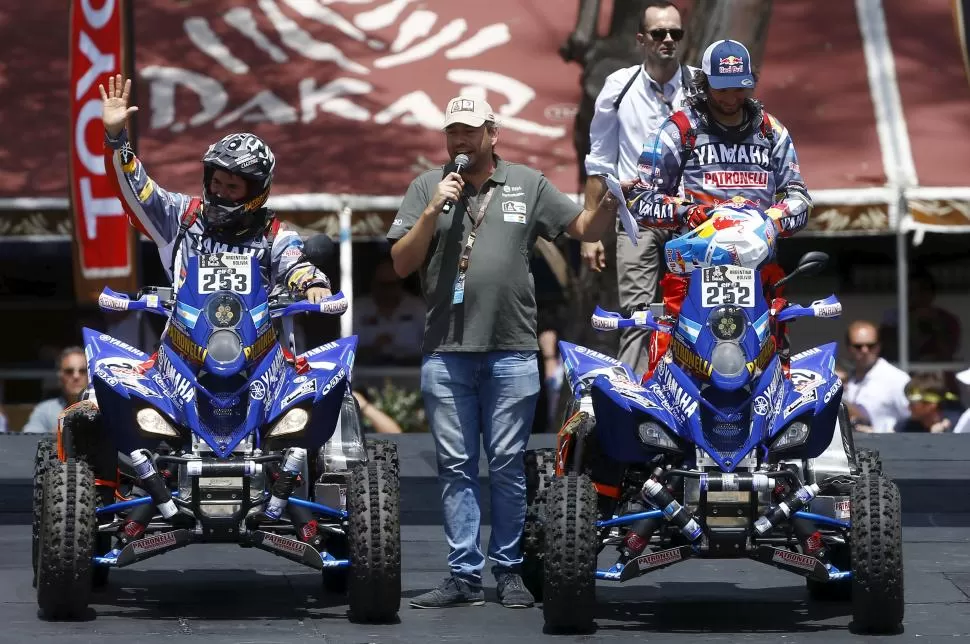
(542, 473, 597, 632)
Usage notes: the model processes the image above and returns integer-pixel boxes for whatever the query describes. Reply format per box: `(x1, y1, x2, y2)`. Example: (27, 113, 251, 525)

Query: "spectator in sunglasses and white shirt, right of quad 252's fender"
(843, 320, 909, 433)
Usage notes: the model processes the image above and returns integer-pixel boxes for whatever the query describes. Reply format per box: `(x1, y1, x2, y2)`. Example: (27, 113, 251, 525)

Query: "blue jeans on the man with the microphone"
(421, 351, 539, 586)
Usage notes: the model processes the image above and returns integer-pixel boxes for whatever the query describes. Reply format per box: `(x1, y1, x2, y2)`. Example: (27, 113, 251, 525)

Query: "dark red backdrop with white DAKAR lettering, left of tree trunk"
(133, 0, 580, 196)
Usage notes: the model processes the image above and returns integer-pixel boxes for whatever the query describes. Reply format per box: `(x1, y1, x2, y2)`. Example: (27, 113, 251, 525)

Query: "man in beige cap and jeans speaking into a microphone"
(387, 96, 617, 608)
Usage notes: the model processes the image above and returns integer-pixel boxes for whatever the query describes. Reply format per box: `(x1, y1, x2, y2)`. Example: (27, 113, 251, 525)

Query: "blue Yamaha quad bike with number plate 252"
(523, 228, 903, 633)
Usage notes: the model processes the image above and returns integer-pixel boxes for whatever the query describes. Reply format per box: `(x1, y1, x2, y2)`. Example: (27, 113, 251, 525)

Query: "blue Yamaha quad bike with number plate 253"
(33, 240, 401, 622)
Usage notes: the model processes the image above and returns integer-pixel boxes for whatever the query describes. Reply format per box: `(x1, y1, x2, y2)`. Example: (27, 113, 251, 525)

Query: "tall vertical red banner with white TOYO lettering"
(69, 0, 135, 301)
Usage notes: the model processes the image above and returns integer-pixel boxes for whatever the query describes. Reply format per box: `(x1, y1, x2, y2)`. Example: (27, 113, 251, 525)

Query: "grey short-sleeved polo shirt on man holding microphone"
(387, 157, 582, 353)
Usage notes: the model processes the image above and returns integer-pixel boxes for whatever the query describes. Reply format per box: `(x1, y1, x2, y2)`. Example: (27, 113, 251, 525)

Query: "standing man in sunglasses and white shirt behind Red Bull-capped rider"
(582, 0, 694, 373)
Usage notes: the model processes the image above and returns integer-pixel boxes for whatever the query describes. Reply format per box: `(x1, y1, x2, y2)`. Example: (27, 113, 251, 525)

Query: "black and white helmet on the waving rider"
(202, 132, 276, 239)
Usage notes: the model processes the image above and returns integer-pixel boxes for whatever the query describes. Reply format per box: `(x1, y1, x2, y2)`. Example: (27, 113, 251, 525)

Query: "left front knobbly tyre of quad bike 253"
(37, 459, 97, 619)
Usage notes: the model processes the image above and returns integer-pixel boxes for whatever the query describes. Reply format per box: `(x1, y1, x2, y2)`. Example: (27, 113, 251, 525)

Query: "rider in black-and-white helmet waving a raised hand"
(100, 74, 330, 302)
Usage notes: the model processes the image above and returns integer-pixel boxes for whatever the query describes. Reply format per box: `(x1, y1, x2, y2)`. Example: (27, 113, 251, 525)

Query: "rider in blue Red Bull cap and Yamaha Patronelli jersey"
(628, 40, 812, 375)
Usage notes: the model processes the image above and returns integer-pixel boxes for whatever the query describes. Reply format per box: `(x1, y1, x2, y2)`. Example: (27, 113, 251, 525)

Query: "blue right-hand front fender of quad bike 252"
(771, 342, 843, 458)
